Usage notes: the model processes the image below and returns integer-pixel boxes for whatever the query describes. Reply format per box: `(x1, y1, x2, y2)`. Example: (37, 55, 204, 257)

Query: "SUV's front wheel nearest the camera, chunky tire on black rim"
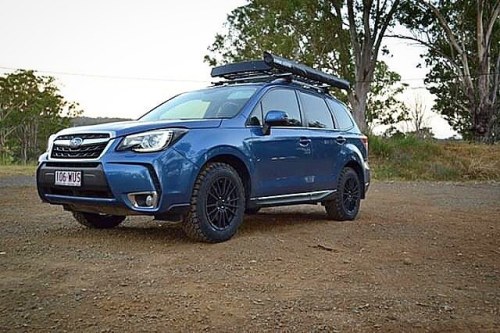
(182, 163, 246, 243)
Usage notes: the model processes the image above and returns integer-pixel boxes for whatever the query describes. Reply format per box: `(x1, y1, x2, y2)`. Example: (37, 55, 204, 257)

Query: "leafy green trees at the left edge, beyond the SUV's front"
(0, 70, 79, 163)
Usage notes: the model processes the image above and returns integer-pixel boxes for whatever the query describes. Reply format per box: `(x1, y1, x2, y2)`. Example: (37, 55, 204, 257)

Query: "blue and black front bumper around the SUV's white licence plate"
(37, 149, 197, 216)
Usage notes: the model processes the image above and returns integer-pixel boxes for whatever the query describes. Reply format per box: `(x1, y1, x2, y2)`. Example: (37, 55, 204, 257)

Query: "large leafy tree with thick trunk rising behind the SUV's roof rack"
(205, 0, 400, 130)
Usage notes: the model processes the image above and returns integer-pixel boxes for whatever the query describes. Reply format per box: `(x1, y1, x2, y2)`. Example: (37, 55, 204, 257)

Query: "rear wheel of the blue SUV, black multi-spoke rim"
(325, 167, 361, 221)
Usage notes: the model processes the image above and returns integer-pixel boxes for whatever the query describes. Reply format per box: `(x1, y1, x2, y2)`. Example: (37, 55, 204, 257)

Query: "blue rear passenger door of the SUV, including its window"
(299, 91, 344, 191)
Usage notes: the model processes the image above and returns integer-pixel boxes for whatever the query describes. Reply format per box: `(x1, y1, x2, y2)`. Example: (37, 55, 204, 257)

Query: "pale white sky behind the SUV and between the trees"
(0, 0, 453, 137)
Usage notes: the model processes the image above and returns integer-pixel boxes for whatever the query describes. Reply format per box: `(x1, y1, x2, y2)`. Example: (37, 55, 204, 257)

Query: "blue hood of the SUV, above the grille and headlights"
(57, 119, 222, 137)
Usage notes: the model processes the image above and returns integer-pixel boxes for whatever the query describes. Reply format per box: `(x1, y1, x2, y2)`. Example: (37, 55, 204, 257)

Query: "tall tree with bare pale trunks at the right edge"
(399, 0, 500, 142)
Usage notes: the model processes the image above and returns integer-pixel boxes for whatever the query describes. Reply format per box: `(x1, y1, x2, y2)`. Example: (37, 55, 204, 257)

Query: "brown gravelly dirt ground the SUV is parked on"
(0, 182, 500, 332)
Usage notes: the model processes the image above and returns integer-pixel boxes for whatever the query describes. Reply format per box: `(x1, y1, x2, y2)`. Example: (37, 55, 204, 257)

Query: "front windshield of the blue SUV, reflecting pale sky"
(139, 86, 257, 121)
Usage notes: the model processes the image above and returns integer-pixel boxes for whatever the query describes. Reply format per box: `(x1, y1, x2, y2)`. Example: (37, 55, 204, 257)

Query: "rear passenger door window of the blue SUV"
(299, 92, 333, 129)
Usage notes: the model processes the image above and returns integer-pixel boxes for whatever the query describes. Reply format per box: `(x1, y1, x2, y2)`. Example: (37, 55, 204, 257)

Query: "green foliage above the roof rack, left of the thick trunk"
(205, 0, 353, 79)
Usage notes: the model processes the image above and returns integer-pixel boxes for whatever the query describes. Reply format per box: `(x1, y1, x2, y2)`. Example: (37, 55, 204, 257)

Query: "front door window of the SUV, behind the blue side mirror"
(262, 89, 302, 126)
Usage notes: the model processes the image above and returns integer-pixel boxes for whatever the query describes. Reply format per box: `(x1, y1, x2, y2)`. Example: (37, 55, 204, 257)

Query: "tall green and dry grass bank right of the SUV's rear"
(369, 136, 500, 181)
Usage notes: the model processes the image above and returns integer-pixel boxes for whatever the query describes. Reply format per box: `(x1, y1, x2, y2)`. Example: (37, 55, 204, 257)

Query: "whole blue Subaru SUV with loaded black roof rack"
(37, 53, 370, 242)
